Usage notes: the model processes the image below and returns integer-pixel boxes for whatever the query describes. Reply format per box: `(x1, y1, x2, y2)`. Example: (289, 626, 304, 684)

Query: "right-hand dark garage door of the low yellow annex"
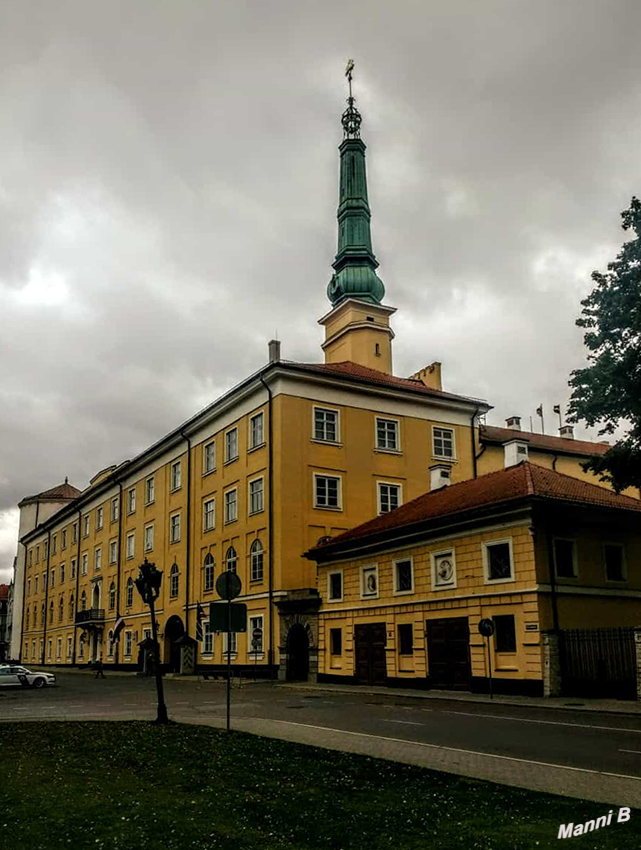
(425, 617, 471, 691)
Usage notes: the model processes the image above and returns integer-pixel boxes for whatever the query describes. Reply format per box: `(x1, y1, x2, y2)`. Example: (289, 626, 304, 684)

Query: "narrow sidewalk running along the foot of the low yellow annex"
(277, 682, 641, 718)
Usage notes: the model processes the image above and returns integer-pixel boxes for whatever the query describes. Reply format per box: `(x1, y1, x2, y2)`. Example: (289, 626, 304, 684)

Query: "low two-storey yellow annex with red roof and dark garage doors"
(307, 461, 641, 696)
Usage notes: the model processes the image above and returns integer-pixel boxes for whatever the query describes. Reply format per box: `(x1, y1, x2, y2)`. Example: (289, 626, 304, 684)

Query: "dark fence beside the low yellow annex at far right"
(559, 628, 636, 699)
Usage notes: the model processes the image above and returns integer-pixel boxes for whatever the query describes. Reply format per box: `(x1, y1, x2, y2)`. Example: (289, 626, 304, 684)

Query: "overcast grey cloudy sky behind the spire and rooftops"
(0, 0, 641, 581)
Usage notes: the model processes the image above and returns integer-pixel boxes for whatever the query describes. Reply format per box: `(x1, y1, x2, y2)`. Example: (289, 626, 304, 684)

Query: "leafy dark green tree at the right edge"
(568, 197, 641, 493)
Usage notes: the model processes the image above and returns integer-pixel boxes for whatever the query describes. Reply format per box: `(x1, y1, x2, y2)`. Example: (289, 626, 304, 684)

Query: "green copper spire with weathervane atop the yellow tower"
(327, 59, 385, 307)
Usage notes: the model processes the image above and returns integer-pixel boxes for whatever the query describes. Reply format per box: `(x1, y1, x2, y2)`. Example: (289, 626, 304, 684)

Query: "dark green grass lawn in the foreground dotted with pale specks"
(0, 722, 641, 850)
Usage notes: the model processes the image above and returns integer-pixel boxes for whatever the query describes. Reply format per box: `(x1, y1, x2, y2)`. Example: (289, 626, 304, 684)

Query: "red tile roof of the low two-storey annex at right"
(308, 461, 641, 558)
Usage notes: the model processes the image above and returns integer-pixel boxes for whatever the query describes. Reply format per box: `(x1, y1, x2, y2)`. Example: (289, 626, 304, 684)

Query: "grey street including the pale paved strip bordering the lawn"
(0, 673, 641, 805)
